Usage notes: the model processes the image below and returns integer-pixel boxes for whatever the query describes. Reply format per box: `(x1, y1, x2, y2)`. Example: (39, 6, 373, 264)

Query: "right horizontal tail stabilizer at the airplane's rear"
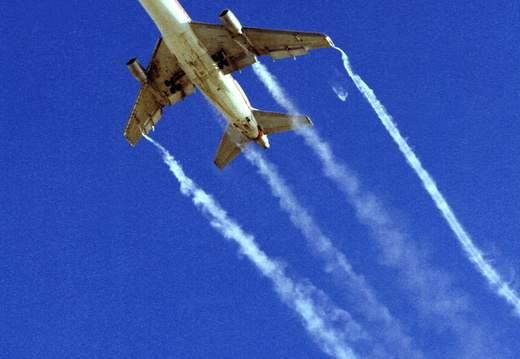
(253, 110, 312, 135)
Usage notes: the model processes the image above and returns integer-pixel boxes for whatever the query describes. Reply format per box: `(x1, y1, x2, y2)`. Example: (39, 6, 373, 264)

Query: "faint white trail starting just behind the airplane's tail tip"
(244, 148, 424, 359)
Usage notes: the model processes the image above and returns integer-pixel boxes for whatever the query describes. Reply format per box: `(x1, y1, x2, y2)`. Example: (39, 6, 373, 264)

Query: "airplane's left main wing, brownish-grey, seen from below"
(123, 38, 195, 146)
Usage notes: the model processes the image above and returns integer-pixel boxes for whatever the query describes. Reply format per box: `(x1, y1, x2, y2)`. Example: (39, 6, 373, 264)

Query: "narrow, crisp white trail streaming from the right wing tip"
(335, 47, 520, 316)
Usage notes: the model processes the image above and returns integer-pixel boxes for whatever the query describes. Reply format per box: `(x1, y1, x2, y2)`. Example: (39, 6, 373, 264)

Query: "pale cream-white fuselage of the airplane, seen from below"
(139, 0, 269, 148)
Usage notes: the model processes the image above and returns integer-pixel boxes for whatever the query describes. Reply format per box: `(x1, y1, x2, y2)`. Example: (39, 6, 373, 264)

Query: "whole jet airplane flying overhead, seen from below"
(123, 0, 334, 169)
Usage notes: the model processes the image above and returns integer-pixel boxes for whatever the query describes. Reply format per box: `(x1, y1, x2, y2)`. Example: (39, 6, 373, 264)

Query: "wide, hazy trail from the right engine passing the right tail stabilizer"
(253, 62, 504, 358)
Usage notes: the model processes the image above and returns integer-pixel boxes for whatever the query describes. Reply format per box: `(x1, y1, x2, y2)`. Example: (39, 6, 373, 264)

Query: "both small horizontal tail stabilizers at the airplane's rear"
(213, 110, 312, 169)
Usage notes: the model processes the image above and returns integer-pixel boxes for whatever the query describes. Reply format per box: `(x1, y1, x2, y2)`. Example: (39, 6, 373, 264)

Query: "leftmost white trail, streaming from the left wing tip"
(144, 136, 367, 359)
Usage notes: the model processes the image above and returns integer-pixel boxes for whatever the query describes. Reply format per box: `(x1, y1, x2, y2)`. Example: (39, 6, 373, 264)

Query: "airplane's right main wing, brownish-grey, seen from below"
(190, 22, 333, 73)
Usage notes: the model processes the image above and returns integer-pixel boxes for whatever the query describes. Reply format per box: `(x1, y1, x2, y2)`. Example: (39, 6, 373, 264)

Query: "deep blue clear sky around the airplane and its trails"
(0, 0, 520, 358)
